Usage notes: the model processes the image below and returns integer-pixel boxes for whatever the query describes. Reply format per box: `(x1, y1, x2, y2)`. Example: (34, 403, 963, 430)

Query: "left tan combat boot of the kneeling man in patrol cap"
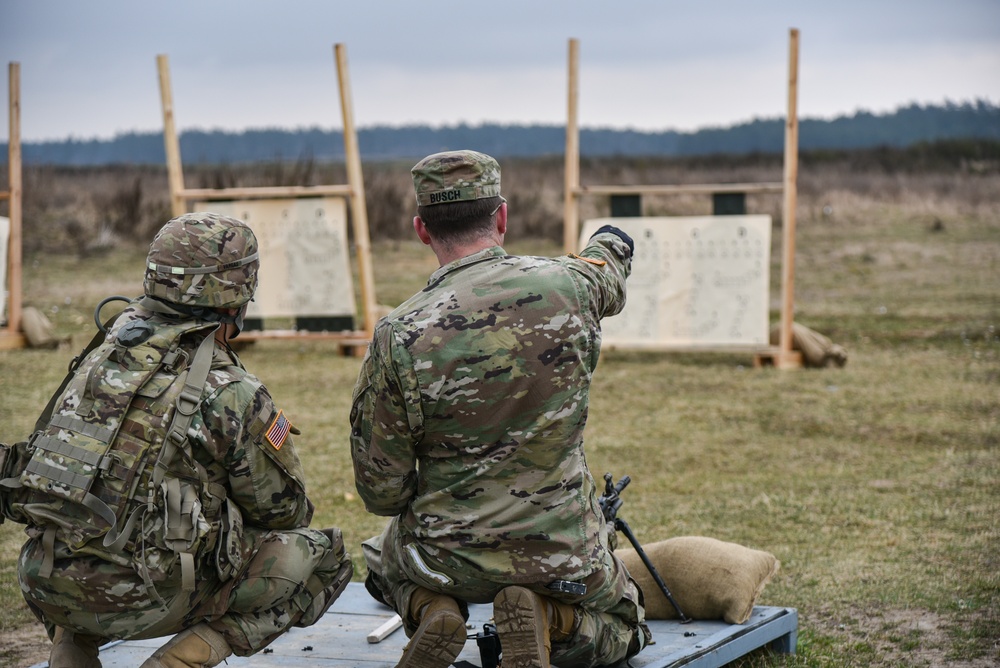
(396, 588, 465, 668)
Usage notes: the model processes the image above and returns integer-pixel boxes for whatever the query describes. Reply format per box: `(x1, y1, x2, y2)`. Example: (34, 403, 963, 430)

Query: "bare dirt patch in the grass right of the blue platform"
(803, 608, 1000, 668)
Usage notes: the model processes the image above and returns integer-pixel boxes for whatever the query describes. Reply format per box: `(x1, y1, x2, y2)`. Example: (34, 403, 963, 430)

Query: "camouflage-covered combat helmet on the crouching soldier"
(143, 212, 260, 308)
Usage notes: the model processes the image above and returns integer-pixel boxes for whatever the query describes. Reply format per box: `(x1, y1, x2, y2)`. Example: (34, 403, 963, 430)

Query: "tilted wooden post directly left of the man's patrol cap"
(333, 44, 376, 337)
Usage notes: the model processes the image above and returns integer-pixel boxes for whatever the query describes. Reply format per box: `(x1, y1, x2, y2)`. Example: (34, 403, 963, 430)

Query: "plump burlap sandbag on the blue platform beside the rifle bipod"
(615, 536, 780, 624)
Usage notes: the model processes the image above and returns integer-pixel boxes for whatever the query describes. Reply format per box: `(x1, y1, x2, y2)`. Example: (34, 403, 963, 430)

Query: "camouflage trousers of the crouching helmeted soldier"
(18, 528, 353, 656)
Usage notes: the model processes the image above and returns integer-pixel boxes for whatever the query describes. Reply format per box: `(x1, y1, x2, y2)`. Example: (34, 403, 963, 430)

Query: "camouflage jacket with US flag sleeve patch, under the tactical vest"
(15, 305, 314, 579)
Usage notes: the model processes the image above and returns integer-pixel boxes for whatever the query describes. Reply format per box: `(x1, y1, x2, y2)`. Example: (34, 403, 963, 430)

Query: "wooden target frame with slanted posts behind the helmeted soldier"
(156, 44, 377, 348)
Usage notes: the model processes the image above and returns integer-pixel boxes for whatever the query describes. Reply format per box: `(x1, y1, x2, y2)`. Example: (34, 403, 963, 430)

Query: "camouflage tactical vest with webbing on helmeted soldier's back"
(9, 307, 221, 553)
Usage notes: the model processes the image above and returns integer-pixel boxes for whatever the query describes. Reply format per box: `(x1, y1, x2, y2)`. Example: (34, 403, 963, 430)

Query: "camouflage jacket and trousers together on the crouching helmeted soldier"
(18, 304, 351, 654)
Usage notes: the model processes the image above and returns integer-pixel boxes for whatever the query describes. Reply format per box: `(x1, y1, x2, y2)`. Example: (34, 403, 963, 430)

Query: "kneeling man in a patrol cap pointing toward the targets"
(351, 150, 650, 668)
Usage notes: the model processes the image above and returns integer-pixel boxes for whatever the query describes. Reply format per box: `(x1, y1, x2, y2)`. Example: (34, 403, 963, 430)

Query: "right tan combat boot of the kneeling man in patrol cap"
(493, 587, 575, 668)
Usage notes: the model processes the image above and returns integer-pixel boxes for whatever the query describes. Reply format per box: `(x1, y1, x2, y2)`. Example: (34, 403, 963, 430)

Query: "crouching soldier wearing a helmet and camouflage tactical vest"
(11, 213, 352, 668)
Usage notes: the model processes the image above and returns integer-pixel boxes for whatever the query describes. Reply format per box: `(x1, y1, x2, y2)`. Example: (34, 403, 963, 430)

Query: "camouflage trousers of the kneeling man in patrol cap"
(362, 517, 652, 668)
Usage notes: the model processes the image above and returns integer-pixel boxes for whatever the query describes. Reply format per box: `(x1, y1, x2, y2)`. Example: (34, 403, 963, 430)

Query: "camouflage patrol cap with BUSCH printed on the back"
(410, 150, 500, 206)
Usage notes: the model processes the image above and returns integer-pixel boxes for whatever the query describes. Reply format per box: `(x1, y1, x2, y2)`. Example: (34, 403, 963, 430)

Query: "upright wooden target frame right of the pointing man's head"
(563, 28, 802, 369)
